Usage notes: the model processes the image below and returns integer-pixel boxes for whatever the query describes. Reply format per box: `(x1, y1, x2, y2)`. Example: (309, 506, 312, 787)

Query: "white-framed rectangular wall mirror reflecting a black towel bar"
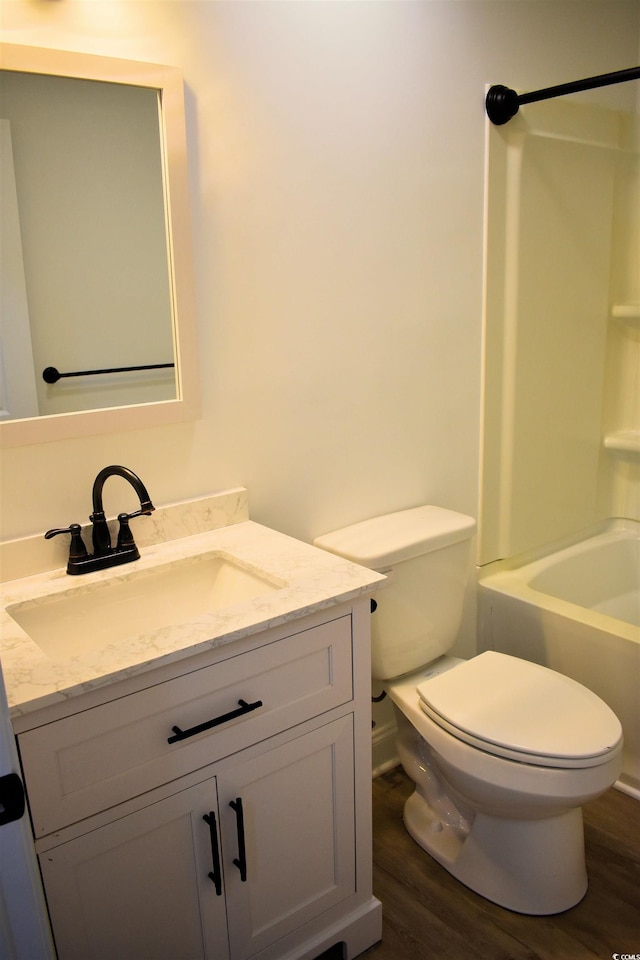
(0, 44, 197, 446)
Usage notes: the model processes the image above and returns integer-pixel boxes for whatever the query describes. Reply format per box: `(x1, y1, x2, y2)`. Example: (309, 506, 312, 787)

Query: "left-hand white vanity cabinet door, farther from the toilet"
(40, 778, 229, 960)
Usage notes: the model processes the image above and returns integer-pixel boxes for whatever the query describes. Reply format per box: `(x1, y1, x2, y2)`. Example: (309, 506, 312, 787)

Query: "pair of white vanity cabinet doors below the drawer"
(40, 717, 355, 960)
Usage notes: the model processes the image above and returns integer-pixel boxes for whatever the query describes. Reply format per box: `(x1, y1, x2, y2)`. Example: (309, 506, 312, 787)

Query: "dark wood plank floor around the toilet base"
(362, 767, 640, 960)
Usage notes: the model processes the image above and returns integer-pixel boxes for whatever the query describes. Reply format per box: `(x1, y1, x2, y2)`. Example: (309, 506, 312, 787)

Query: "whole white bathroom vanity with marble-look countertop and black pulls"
(0, 492, 382, 960)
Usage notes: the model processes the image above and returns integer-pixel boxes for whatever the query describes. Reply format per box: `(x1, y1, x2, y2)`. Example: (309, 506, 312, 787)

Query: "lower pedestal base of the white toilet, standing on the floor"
(404, 791, 587, 916)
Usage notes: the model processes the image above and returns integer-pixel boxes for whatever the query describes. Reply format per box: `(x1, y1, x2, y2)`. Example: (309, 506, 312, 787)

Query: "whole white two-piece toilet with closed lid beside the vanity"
(314, 506, 622, 914)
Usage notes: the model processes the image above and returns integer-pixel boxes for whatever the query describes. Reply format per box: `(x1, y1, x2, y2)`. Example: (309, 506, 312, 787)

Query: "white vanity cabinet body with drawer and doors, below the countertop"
(17, 598, 380, 960)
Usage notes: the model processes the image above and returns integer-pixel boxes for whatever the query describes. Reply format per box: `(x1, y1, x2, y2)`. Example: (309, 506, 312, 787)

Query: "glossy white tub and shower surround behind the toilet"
(478, 92, 640, 798)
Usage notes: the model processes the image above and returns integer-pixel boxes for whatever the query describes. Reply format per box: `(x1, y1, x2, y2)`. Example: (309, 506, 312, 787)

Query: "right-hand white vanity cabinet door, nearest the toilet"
(218, 715, 355, 960)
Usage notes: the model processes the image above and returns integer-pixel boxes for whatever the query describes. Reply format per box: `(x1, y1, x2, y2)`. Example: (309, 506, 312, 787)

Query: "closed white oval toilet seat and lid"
(417, 651, 622, 767)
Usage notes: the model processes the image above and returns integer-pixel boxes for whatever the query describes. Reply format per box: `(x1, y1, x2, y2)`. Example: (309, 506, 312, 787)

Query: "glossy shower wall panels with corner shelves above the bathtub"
(479, 101, 639, 564)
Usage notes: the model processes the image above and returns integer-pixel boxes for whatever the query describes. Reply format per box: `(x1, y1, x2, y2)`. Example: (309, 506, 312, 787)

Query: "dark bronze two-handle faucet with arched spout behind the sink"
(44, 464, 155, 575)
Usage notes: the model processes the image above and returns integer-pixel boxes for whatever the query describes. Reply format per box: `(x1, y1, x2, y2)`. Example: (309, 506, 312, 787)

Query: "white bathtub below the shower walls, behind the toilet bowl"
(478, 520, 640, 799)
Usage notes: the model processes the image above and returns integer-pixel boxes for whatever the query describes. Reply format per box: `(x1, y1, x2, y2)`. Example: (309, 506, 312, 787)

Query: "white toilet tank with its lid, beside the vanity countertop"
(314, 506, 476, 680)
